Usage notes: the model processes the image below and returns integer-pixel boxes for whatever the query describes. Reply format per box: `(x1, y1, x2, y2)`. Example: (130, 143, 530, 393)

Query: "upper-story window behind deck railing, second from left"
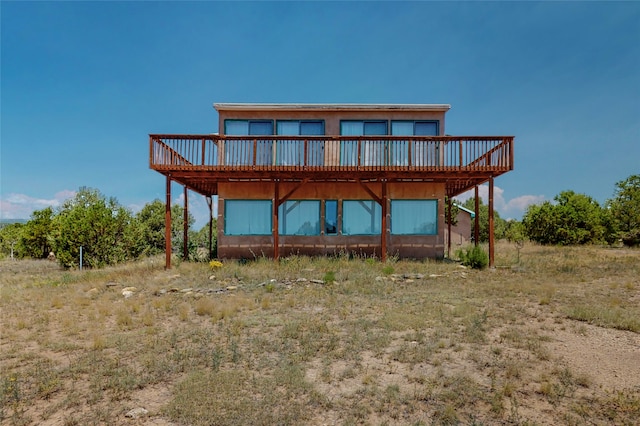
(276, 120, 324, 166)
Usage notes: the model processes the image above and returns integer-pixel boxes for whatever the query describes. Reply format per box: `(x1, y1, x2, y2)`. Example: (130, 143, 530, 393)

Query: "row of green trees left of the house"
(0, 188, 216, 268)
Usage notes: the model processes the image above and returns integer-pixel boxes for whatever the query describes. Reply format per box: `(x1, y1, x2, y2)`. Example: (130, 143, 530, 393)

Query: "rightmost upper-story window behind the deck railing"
(389, 120, 440, 166)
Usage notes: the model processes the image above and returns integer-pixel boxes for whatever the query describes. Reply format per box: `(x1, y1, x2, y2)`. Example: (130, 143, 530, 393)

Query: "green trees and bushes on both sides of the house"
(0, 175, 640, 268)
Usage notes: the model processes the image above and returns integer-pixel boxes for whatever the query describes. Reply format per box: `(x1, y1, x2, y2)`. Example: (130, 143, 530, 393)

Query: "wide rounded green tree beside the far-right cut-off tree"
(522, 191, 607, 245)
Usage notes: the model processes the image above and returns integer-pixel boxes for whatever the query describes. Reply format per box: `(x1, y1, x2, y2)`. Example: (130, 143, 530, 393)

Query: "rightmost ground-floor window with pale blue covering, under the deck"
(391, 200, 438, 235)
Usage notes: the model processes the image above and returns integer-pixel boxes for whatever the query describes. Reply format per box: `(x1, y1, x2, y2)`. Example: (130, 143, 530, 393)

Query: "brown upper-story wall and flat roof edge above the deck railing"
(213, 103, 451, 136)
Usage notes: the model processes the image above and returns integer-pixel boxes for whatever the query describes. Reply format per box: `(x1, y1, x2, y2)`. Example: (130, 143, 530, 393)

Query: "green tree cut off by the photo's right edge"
(607, 174, 640, 246)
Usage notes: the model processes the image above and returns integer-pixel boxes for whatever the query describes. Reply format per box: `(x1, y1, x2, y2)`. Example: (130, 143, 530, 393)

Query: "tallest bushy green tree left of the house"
(54, 188, 135, 268)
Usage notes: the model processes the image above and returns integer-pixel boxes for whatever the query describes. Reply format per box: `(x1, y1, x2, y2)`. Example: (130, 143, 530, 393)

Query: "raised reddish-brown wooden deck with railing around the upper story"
(149, 134, 514, 197)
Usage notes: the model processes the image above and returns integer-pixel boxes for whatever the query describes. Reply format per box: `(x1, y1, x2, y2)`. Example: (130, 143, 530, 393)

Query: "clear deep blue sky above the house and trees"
(0, 1, 640, 226)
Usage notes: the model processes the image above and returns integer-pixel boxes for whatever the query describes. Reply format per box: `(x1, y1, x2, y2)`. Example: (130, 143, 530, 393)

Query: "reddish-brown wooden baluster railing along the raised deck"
(149, 135, 513, 172)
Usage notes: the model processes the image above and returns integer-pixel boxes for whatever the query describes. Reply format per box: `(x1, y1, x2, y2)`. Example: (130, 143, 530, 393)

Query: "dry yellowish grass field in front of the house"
(0, 244, 640, 425)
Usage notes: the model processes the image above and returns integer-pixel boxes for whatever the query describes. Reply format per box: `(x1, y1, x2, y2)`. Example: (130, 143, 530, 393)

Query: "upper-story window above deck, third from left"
(340, 120, 387, 166)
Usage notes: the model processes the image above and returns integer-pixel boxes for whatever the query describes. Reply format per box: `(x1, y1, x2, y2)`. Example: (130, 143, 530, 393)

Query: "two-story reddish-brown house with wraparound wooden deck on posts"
(149, 103, 514, 267)
